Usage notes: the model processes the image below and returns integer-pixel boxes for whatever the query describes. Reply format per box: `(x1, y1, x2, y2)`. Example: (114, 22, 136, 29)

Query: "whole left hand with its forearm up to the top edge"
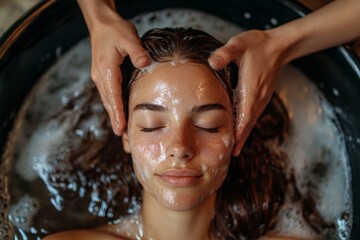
(78, 0, 151, 135)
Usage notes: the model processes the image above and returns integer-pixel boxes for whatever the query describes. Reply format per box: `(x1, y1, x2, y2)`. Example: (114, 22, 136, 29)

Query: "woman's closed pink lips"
(157, 169, 203, 187)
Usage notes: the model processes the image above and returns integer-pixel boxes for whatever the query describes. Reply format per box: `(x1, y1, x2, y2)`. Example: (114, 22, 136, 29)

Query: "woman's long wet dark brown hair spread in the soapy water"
(47, 28, 289, 240)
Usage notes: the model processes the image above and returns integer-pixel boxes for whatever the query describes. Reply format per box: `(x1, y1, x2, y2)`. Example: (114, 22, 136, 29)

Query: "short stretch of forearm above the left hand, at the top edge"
(77, 0, 120, 32)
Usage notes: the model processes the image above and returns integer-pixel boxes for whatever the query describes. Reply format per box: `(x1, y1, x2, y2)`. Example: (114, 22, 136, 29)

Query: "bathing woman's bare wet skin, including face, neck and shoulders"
(45, 63, 306, 240)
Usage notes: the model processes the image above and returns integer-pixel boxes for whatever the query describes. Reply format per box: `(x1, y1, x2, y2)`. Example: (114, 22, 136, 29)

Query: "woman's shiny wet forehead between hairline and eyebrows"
(130, 62, 229, 103)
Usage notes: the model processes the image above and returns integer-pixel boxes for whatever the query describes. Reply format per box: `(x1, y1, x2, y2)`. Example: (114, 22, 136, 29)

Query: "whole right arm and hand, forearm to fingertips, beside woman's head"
(209, 0, 360, 155)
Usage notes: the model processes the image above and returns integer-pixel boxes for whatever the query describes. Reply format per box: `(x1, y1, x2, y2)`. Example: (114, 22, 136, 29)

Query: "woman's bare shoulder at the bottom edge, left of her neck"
(43, 229, 129, 240)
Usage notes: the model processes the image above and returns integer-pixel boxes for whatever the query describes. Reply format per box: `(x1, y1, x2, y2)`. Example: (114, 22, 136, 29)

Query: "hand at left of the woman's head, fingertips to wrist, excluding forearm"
(91, 19, 150, 135)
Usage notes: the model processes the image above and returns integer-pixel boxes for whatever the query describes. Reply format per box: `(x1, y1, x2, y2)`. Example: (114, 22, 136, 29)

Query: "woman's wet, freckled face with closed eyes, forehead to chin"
(123, 63, 234, 211)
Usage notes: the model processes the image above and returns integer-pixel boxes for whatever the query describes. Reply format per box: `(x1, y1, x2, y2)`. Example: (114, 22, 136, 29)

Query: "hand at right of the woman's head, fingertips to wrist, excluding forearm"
(209, 30, 285, 156)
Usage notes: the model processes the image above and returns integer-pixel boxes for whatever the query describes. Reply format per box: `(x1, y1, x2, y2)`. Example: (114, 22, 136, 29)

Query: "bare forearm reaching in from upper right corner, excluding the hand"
(269, 0, 360, 64)
